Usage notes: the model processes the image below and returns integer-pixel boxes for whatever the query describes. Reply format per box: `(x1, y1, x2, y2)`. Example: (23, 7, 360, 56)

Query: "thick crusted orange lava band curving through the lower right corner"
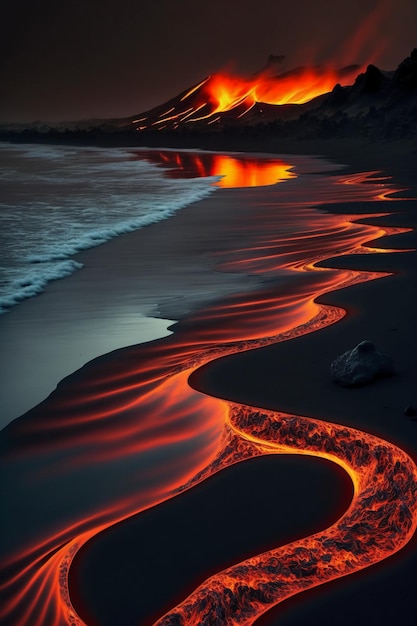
(157, 405, 417, 626)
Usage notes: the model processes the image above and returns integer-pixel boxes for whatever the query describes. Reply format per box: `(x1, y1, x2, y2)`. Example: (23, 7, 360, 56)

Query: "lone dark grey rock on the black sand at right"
(330, 341, 394, 387)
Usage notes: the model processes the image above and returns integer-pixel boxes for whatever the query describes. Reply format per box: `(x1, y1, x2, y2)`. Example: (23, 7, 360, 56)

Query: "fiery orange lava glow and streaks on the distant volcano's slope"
(132, 66, 358, 131)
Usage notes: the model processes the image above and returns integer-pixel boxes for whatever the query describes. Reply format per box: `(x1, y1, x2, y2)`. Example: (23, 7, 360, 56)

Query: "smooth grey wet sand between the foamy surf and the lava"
(0, 146, 338, 427)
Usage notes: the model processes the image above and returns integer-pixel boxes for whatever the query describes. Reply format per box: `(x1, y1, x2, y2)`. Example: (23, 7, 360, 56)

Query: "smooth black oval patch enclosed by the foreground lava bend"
(69, 455, 352, 626)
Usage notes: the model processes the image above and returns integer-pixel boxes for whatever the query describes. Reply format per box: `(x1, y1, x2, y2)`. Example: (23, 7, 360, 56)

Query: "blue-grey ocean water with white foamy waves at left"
(0, 143, 218, 314)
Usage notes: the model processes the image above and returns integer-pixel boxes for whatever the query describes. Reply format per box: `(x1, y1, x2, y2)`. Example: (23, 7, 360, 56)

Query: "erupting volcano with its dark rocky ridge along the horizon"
(0, 49, 417, 143)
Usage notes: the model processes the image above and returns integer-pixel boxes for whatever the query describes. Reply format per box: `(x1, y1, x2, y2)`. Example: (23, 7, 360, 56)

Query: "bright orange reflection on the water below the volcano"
(135, 150, 296, 188)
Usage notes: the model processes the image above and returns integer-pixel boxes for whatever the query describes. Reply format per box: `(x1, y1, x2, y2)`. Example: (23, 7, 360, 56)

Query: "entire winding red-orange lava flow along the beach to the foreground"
(0, 152, 417, 626)
